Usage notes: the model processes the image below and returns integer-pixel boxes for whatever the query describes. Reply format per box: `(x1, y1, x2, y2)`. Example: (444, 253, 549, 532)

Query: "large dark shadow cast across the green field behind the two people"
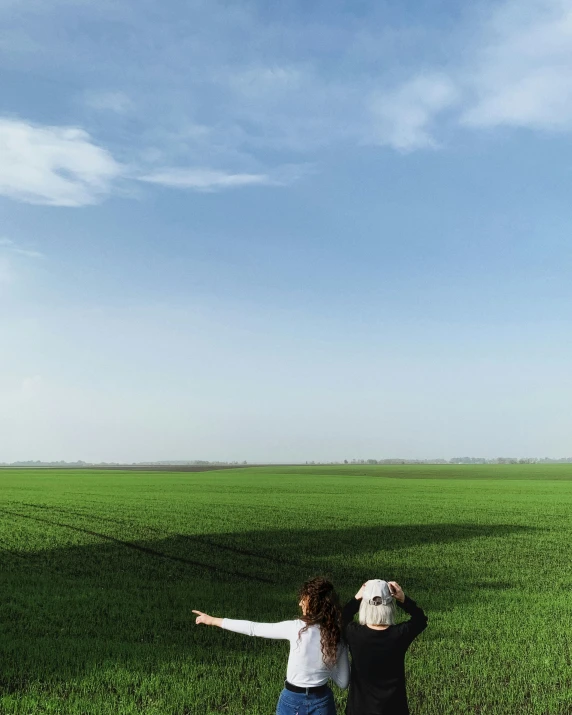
(0, 504, 534, 693)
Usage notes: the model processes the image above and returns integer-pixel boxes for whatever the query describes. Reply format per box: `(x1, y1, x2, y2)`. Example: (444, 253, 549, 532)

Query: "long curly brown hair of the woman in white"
(298, 576, 342, 668)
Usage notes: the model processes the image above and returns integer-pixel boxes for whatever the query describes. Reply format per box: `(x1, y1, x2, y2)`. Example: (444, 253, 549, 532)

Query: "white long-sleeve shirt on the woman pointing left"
(222, 618, 350, 688)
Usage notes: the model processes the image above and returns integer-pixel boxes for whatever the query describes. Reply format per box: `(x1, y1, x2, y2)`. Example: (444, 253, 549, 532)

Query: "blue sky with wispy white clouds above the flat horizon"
(0, 0, 572, 461)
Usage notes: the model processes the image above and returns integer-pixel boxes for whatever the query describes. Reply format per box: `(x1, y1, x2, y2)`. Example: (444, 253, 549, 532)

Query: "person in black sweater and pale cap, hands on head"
(342, 579, 427, 715)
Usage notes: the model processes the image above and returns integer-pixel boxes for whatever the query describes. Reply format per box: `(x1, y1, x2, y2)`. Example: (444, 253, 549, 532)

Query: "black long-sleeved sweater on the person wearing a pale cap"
(343, 596, 427, 715)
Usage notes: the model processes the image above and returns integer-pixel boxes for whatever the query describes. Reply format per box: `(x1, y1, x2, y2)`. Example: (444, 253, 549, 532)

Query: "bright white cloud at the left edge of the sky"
(0, 118, 122, 206)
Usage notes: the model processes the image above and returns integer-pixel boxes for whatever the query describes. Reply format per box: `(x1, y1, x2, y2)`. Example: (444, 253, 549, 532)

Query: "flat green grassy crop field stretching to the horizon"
(0, 465, 572, 715)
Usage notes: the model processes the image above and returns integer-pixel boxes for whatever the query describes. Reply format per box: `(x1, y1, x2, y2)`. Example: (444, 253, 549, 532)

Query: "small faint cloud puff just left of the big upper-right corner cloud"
(371, 74, 458, 151)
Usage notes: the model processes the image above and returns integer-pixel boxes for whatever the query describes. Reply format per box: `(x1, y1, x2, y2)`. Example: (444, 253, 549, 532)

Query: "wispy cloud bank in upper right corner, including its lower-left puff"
(364, 0, 572, 146)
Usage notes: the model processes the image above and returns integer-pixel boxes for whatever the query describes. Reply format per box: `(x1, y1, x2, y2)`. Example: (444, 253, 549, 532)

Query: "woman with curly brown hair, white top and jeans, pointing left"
(193, 577, 349, 715)
